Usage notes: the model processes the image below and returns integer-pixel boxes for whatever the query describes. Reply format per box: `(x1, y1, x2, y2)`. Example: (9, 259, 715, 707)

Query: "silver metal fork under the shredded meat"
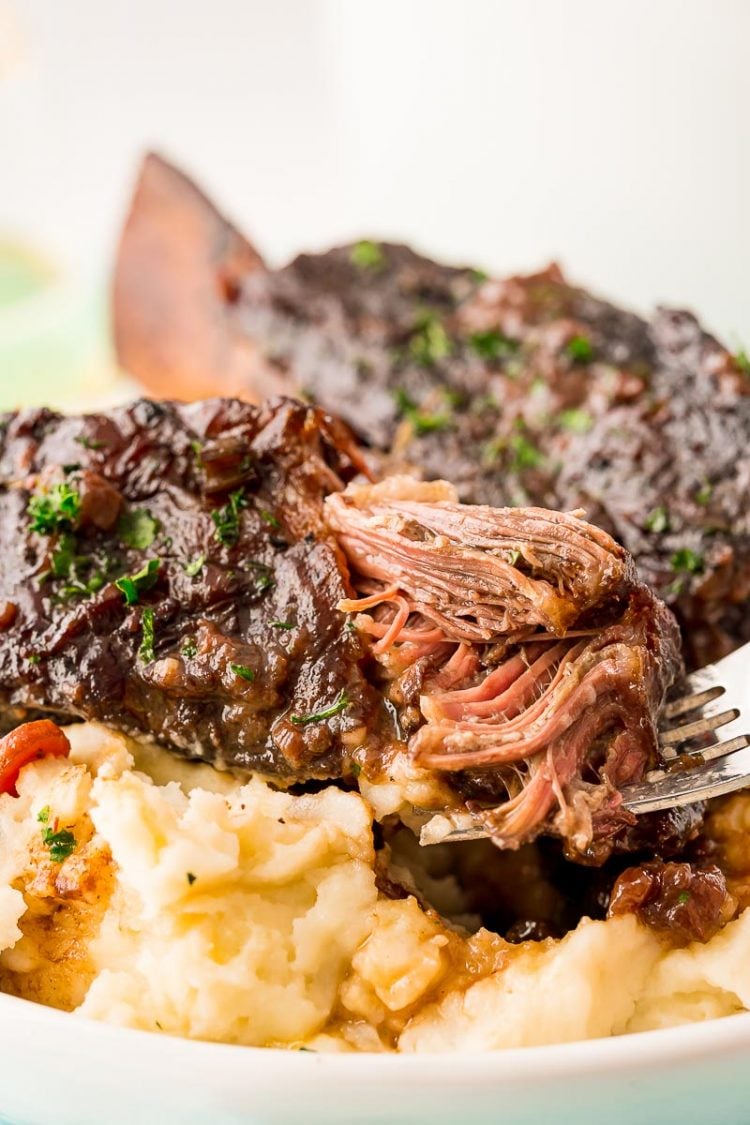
(419, 644, 750, 844)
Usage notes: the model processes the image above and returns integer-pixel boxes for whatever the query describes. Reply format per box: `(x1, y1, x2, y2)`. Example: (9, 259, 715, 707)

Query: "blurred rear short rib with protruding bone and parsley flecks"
(114, 156, 750, 665)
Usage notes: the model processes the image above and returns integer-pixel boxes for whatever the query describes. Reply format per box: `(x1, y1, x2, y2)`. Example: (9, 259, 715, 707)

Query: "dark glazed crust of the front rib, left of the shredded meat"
(0, 399, 381, 780)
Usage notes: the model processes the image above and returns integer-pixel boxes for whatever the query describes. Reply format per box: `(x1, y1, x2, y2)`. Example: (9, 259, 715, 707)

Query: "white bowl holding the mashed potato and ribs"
(0, 996, 750, 1125)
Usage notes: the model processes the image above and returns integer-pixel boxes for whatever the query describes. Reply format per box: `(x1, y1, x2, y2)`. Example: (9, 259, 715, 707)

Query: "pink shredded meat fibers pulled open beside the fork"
(326, 477, 680, 860)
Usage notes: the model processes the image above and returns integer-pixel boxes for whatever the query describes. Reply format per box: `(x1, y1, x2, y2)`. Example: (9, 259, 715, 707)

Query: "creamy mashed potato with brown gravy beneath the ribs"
(0, 723, 750, 1051)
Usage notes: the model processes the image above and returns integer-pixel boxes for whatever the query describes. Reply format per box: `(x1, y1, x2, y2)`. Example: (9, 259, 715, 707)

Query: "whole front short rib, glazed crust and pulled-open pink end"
(0, 399, 680, 860)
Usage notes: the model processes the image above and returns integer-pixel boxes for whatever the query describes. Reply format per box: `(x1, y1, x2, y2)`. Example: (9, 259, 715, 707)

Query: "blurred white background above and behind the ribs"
(0, 0, 750, 407)
